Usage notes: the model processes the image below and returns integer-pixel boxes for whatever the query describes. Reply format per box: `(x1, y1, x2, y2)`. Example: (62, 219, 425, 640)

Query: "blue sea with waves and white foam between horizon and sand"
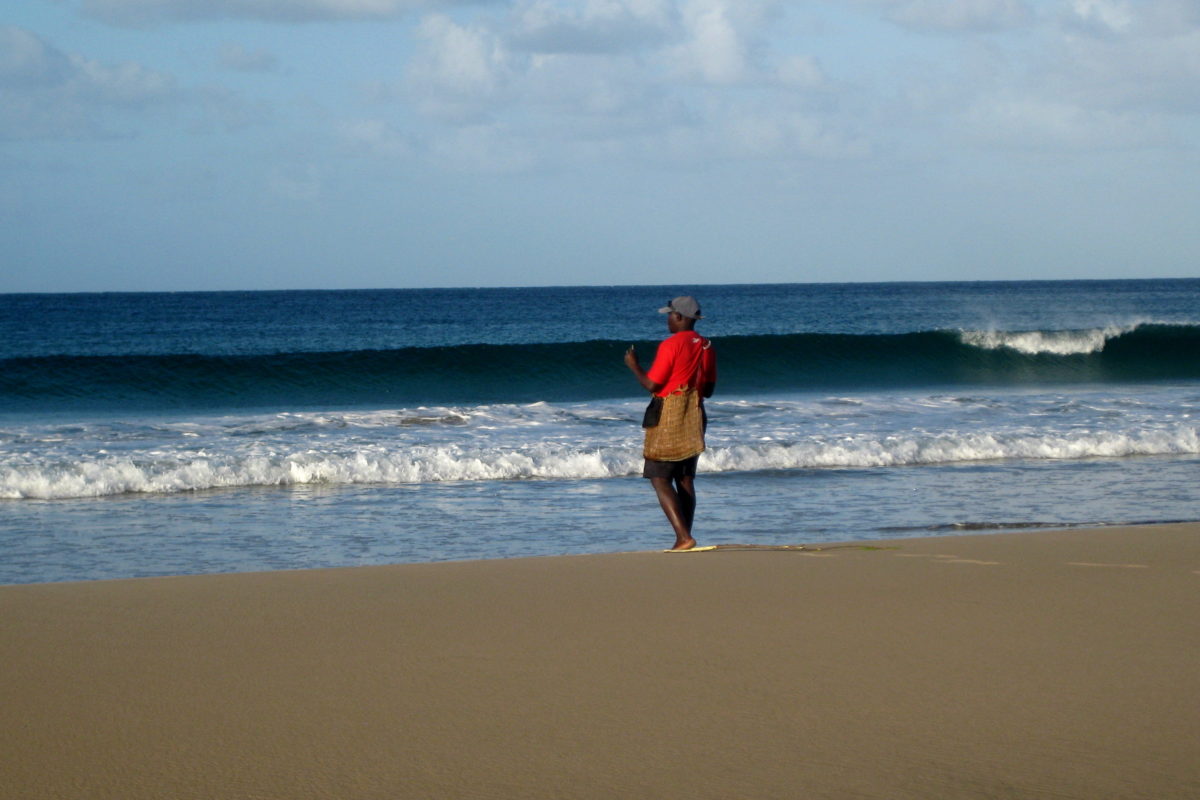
(0, 279, 1200, 583)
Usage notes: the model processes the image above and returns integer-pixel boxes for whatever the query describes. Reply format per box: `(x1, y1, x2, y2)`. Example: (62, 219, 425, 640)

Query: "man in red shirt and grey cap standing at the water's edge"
(625, 296, 716, 551)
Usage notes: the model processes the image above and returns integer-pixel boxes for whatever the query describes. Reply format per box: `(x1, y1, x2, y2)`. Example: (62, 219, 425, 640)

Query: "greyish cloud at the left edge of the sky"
(0, 25, 185, 139)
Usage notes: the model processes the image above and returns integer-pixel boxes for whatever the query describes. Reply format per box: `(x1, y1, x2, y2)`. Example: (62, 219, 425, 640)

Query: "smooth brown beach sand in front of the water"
(0, 524, 1200, 800)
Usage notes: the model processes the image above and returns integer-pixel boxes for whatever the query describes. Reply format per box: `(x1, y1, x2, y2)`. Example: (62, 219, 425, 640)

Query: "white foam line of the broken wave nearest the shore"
(0, 423, 1200, 499)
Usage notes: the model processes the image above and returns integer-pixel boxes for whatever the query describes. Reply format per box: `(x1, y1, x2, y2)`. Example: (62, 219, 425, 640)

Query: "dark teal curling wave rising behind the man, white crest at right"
(0, 324, 1200, 410)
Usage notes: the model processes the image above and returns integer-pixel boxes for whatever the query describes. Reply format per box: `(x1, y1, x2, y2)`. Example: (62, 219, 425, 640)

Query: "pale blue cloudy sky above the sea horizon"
(0, 0, 1200, 293)
